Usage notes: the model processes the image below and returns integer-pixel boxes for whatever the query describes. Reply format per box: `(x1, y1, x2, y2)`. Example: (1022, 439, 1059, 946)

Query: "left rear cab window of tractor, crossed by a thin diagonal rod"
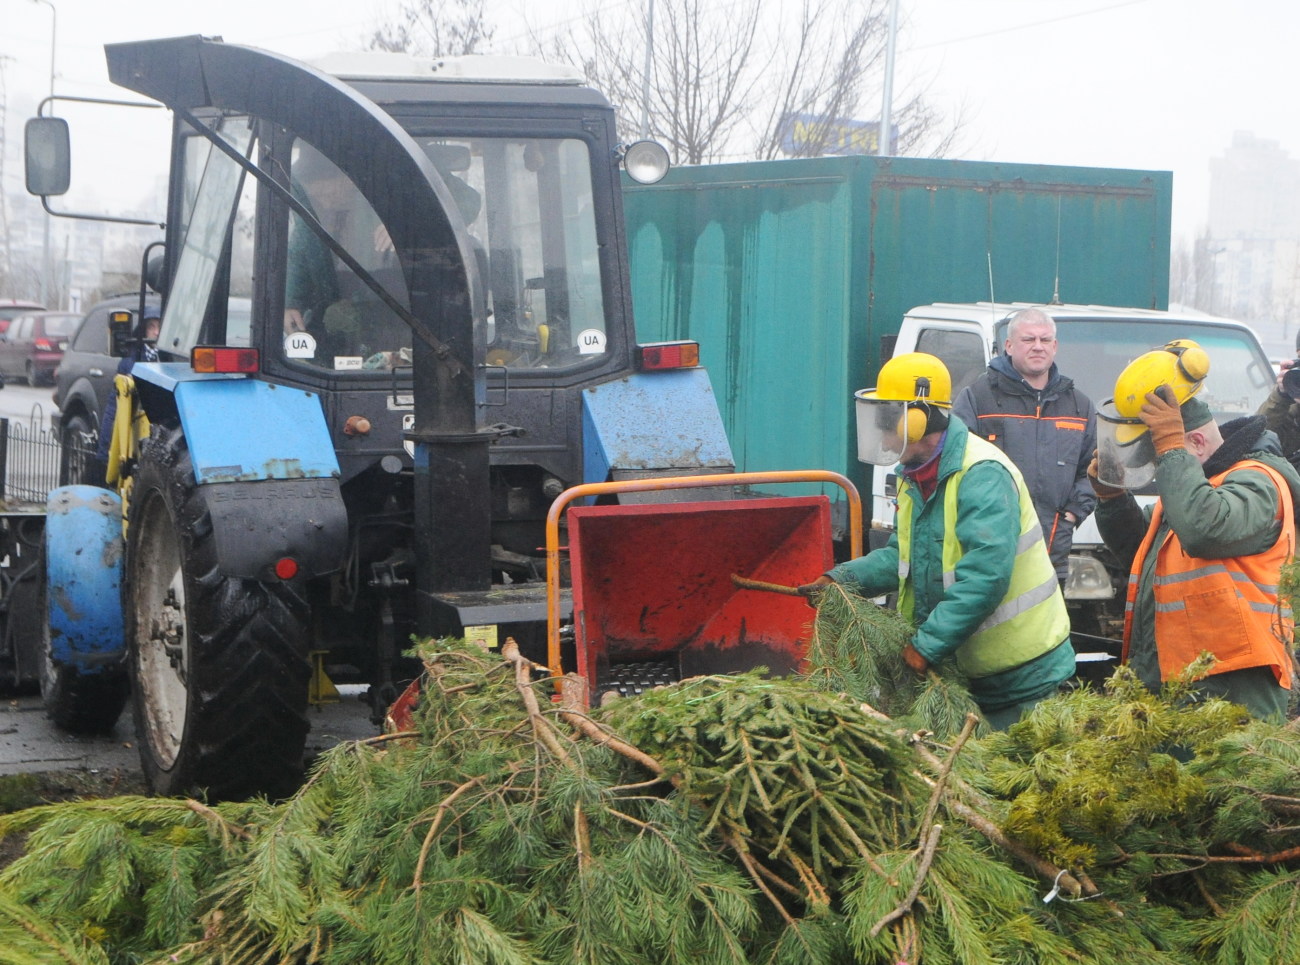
(283, 140, 411, 372)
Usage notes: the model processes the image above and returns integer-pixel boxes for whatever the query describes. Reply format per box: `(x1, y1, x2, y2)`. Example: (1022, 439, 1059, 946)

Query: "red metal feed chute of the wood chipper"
(568, 496, 833, 702)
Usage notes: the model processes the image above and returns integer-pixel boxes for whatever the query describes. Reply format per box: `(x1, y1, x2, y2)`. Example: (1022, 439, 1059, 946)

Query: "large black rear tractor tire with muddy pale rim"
(125, 427, 311, 800)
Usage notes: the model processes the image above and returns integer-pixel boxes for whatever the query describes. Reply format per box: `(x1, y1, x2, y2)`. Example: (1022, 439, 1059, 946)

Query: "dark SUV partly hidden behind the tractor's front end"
(55, 295, 159, 473)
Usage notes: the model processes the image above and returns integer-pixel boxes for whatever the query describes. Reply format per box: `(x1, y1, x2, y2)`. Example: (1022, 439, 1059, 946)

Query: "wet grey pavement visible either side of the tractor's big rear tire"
(0, 687, 378, 778)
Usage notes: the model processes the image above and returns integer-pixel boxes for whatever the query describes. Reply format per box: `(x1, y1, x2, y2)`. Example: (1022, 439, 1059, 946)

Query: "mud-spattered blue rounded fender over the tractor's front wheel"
(46, 485, 126, 674)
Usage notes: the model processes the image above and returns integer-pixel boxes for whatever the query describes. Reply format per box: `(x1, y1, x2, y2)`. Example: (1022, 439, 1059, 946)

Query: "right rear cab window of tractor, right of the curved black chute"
(417, 137, 607, 369)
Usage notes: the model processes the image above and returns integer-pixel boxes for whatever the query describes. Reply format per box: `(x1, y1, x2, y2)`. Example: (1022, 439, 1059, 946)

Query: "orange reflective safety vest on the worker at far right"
(1121, 459, 1296, 689)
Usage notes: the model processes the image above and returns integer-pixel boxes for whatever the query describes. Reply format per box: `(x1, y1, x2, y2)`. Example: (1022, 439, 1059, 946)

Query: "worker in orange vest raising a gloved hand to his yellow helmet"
(1088, 339, 1300, 719)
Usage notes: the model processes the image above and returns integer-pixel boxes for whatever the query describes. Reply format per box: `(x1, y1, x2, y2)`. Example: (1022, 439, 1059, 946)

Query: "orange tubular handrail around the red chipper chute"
(546, 469, 862, 676)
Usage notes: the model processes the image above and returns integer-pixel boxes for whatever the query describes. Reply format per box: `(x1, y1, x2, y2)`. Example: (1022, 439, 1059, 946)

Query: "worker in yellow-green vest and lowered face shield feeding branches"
(805, 352, 1074, 727)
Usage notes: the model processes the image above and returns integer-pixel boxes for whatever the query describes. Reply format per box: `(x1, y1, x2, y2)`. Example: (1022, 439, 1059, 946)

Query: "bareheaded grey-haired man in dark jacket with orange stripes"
(953, 308, 1097, 584)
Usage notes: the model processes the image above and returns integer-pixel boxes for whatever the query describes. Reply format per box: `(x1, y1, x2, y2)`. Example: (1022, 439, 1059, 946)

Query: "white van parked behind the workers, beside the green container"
(871, 302, 1275, 650)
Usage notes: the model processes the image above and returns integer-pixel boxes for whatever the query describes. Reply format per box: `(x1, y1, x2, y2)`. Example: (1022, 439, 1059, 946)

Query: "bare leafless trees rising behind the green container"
(540, 0, 959, 164)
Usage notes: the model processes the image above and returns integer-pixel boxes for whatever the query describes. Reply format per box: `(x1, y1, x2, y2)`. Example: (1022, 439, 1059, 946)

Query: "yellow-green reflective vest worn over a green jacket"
(897, 434, 1070, 678)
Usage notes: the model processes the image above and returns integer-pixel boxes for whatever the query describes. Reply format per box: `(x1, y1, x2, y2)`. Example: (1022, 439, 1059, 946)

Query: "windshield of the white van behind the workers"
(1050, 319, 1274, 423)
